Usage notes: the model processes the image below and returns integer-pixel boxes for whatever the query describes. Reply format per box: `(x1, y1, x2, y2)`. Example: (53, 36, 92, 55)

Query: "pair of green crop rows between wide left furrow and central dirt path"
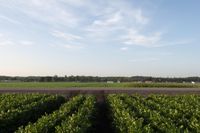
(16, 95, 96, 133)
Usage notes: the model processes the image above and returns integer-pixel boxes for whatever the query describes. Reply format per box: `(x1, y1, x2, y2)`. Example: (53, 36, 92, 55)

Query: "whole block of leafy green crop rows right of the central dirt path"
(107, 95, 200, 133)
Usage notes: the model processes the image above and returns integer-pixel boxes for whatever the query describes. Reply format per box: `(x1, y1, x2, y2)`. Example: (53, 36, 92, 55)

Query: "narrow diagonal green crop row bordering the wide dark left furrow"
(16, 95, 85, 133)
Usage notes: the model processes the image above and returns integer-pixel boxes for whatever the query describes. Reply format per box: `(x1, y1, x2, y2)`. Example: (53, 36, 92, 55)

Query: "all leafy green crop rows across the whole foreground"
(0, 94, 200, 133)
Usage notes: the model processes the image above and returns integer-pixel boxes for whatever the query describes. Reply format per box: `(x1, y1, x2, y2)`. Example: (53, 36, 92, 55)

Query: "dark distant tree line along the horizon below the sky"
(0, 75, 200, 83)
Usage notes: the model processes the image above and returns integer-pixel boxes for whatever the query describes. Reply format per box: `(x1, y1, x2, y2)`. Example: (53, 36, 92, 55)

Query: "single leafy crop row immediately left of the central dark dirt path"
(56, 96, 96, 133)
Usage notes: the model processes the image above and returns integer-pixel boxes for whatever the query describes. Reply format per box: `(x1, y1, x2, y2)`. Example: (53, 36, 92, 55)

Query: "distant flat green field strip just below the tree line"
(0, 82, 200, 89)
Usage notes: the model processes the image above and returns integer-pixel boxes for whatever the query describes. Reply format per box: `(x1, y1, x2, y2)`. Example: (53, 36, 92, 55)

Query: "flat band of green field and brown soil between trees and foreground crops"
(0, 82, 200, 95)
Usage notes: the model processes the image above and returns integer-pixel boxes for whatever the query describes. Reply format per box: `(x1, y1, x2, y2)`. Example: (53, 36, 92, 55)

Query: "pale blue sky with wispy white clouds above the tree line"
(0, 0, 200, 77)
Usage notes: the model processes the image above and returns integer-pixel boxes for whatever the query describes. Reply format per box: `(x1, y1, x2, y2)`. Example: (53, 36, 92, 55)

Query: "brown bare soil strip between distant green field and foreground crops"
(0, 88, 200, 95)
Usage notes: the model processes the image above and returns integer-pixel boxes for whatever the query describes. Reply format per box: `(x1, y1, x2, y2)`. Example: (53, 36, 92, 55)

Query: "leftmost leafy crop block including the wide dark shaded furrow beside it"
(0, 94, 64, 132)
